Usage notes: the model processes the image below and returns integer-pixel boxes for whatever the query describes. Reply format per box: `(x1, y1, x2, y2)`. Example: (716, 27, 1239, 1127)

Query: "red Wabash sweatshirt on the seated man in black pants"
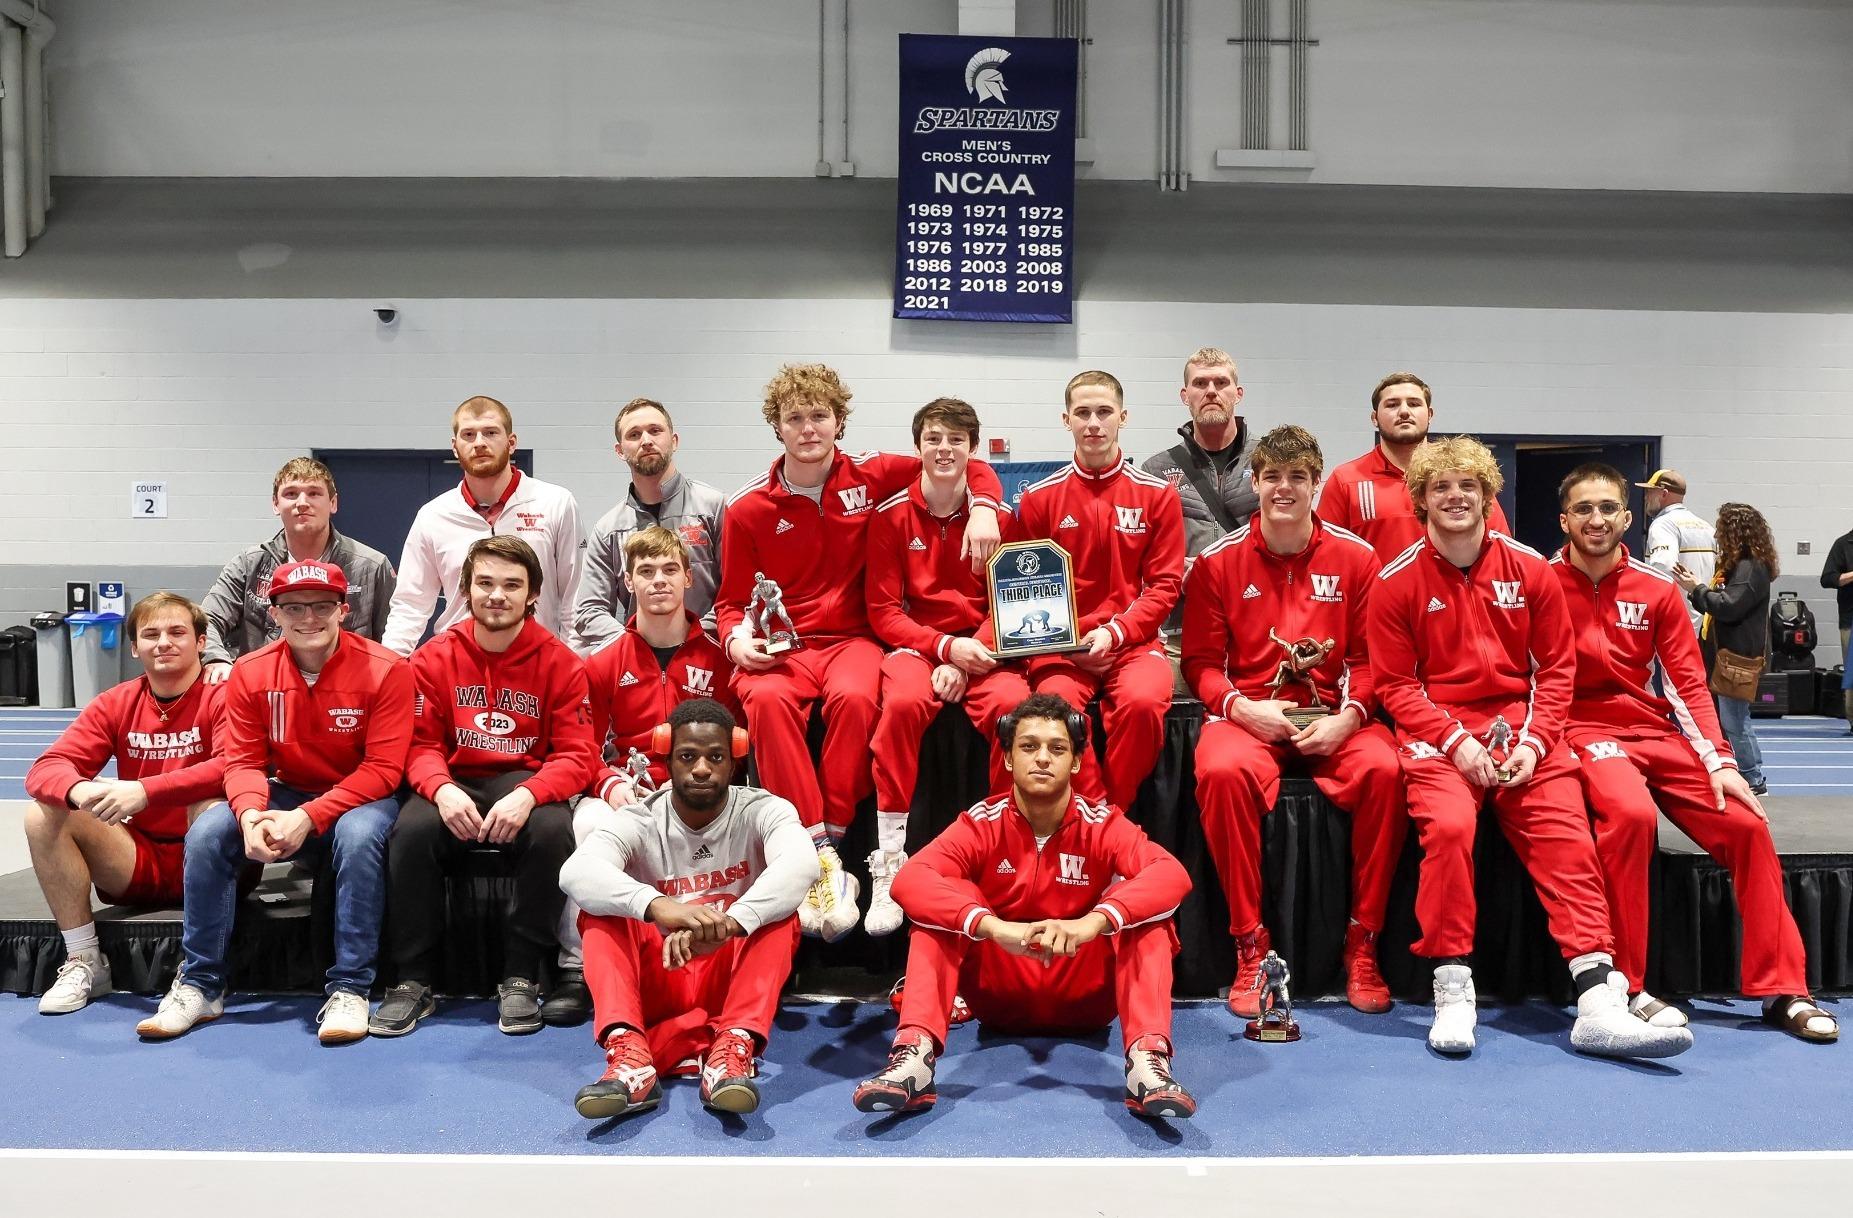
(406, 617, 599, 803)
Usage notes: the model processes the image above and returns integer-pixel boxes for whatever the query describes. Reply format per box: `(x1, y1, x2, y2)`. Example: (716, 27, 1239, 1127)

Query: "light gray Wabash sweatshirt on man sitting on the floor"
(560, 786, 817, 934)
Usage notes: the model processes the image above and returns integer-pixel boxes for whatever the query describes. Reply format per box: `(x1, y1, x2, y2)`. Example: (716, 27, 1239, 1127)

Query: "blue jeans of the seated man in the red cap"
(180, 782, 398, 997)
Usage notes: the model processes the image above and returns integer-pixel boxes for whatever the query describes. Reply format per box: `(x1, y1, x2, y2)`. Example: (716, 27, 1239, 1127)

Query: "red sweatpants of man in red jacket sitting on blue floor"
(897, 915, 1179, 1049)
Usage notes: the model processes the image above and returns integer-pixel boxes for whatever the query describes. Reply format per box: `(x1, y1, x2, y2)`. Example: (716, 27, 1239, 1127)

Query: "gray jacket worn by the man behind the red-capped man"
(200, 527, 398, 664)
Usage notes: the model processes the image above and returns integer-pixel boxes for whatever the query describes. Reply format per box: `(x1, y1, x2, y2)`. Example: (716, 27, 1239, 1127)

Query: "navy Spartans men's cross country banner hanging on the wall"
(895, 33, 1077, 323)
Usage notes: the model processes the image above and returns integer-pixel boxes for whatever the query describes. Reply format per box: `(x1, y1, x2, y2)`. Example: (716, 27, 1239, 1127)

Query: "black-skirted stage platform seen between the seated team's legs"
(0, 701, 1853, 1001)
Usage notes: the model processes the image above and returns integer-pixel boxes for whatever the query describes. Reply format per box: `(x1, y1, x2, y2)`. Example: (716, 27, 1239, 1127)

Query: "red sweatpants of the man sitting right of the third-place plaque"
(1028, 643, 1177, 812)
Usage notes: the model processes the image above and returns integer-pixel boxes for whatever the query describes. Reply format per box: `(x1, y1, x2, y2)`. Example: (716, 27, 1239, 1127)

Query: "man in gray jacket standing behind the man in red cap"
(200, 456, 398, 686)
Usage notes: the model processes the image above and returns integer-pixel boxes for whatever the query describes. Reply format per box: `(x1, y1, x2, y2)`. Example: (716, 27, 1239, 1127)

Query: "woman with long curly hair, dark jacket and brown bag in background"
(1673, 502, 1781, 795)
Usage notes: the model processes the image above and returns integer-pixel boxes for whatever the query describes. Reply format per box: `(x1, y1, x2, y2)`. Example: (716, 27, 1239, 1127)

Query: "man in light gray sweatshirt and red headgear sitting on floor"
(560, 699, 817, 1120)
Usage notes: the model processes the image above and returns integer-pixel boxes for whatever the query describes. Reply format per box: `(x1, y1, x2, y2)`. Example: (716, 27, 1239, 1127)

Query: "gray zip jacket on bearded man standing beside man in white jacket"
(573, 471, 726, 654)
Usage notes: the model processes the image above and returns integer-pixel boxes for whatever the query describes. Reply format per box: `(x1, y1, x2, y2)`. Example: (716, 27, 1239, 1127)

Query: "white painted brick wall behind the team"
(0, 300, 1853, 604)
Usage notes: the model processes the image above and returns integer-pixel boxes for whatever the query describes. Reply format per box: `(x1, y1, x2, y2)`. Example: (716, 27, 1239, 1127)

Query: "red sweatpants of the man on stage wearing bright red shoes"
(1197, 717, 1408, 938)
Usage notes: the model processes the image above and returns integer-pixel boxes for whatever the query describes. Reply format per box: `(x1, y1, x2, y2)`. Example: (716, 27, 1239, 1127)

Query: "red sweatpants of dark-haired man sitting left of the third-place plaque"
(871, 651, 1030, 814)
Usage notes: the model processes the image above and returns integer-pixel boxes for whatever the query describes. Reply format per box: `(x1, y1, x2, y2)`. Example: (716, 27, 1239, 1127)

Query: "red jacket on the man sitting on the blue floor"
(893, 795, 1190, 936)
